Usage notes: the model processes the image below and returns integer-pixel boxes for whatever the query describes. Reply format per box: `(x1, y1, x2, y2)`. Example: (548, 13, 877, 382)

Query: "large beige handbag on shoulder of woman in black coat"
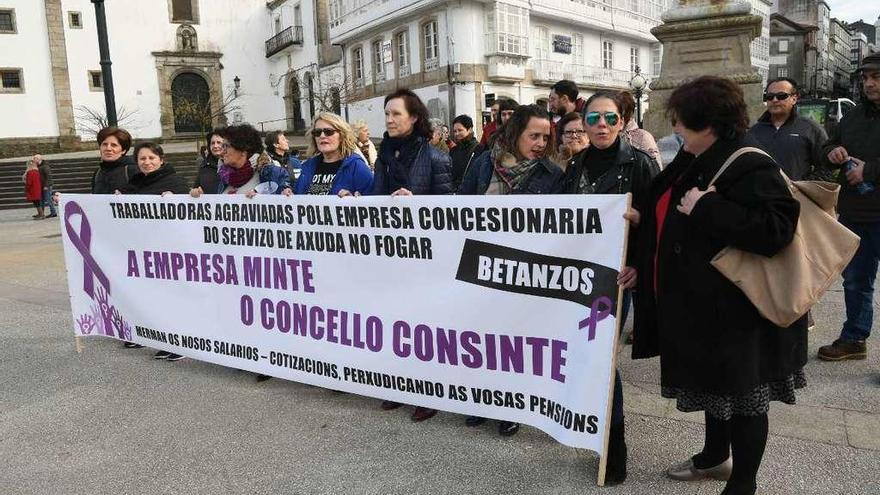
(709, 147, 859, 328)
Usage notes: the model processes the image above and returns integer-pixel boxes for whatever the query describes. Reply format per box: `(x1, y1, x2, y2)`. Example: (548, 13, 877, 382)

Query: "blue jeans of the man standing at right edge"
(840, 216, 880, 341)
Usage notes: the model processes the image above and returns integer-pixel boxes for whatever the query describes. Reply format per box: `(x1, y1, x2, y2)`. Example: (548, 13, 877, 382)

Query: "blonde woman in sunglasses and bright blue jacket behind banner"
(293, 112, 373, 196)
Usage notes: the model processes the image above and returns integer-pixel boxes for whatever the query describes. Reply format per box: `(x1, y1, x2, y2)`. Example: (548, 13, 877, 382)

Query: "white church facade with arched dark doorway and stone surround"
(0, 0, 285, 155)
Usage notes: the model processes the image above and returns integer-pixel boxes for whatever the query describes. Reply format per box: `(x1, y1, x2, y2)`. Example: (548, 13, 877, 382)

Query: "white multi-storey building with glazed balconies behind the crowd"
(329, 0, 667, 135)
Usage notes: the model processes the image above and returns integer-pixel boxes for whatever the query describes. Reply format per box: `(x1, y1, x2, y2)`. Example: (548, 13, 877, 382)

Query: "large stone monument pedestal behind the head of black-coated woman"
(645, 0, 764, 138)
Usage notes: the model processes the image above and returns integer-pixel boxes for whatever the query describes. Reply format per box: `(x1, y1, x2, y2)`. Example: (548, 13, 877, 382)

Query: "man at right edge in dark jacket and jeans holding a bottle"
(819, 54, 880, 361)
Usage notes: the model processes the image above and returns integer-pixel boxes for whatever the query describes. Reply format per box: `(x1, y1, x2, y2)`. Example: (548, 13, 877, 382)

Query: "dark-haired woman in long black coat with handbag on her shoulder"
(633, 76, 807, 495)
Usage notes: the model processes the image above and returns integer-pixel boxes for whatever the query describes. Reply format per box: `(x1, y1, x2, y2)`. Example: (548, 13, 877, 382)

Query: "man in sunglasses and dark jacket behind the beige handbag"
(749, 77, 831, 181)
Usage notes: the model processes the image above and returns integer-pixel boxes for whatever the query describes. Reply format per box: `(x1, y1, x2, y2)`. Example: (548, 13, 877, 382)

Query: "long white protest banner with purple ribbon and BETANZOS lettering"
(61, 194, 628, 453)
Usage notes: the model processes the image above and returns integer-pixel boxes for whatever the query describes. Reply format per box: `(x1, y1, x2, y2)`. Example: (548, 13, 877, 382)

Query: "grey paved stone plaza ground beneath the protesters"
(0, 209, 880, 495)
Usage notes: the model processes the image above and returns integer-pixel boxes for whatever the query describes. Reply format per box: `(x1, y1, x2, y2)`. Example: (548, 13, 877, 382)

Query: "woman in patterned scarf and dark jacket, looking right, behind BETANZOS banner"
(459, 105, 562, 436)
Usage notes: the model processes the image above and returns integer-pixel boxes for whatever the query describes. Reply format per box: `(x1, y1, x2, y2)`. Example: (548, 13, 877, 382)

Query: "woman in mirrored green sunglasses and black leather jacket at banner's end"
(565, 91, 656, 484)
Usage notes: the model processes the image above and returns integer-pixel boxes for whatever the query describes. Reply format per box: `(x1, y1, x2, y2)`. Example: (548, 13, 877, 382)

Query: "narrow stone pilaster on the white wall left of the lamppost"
(45, 0, 79, 149)
